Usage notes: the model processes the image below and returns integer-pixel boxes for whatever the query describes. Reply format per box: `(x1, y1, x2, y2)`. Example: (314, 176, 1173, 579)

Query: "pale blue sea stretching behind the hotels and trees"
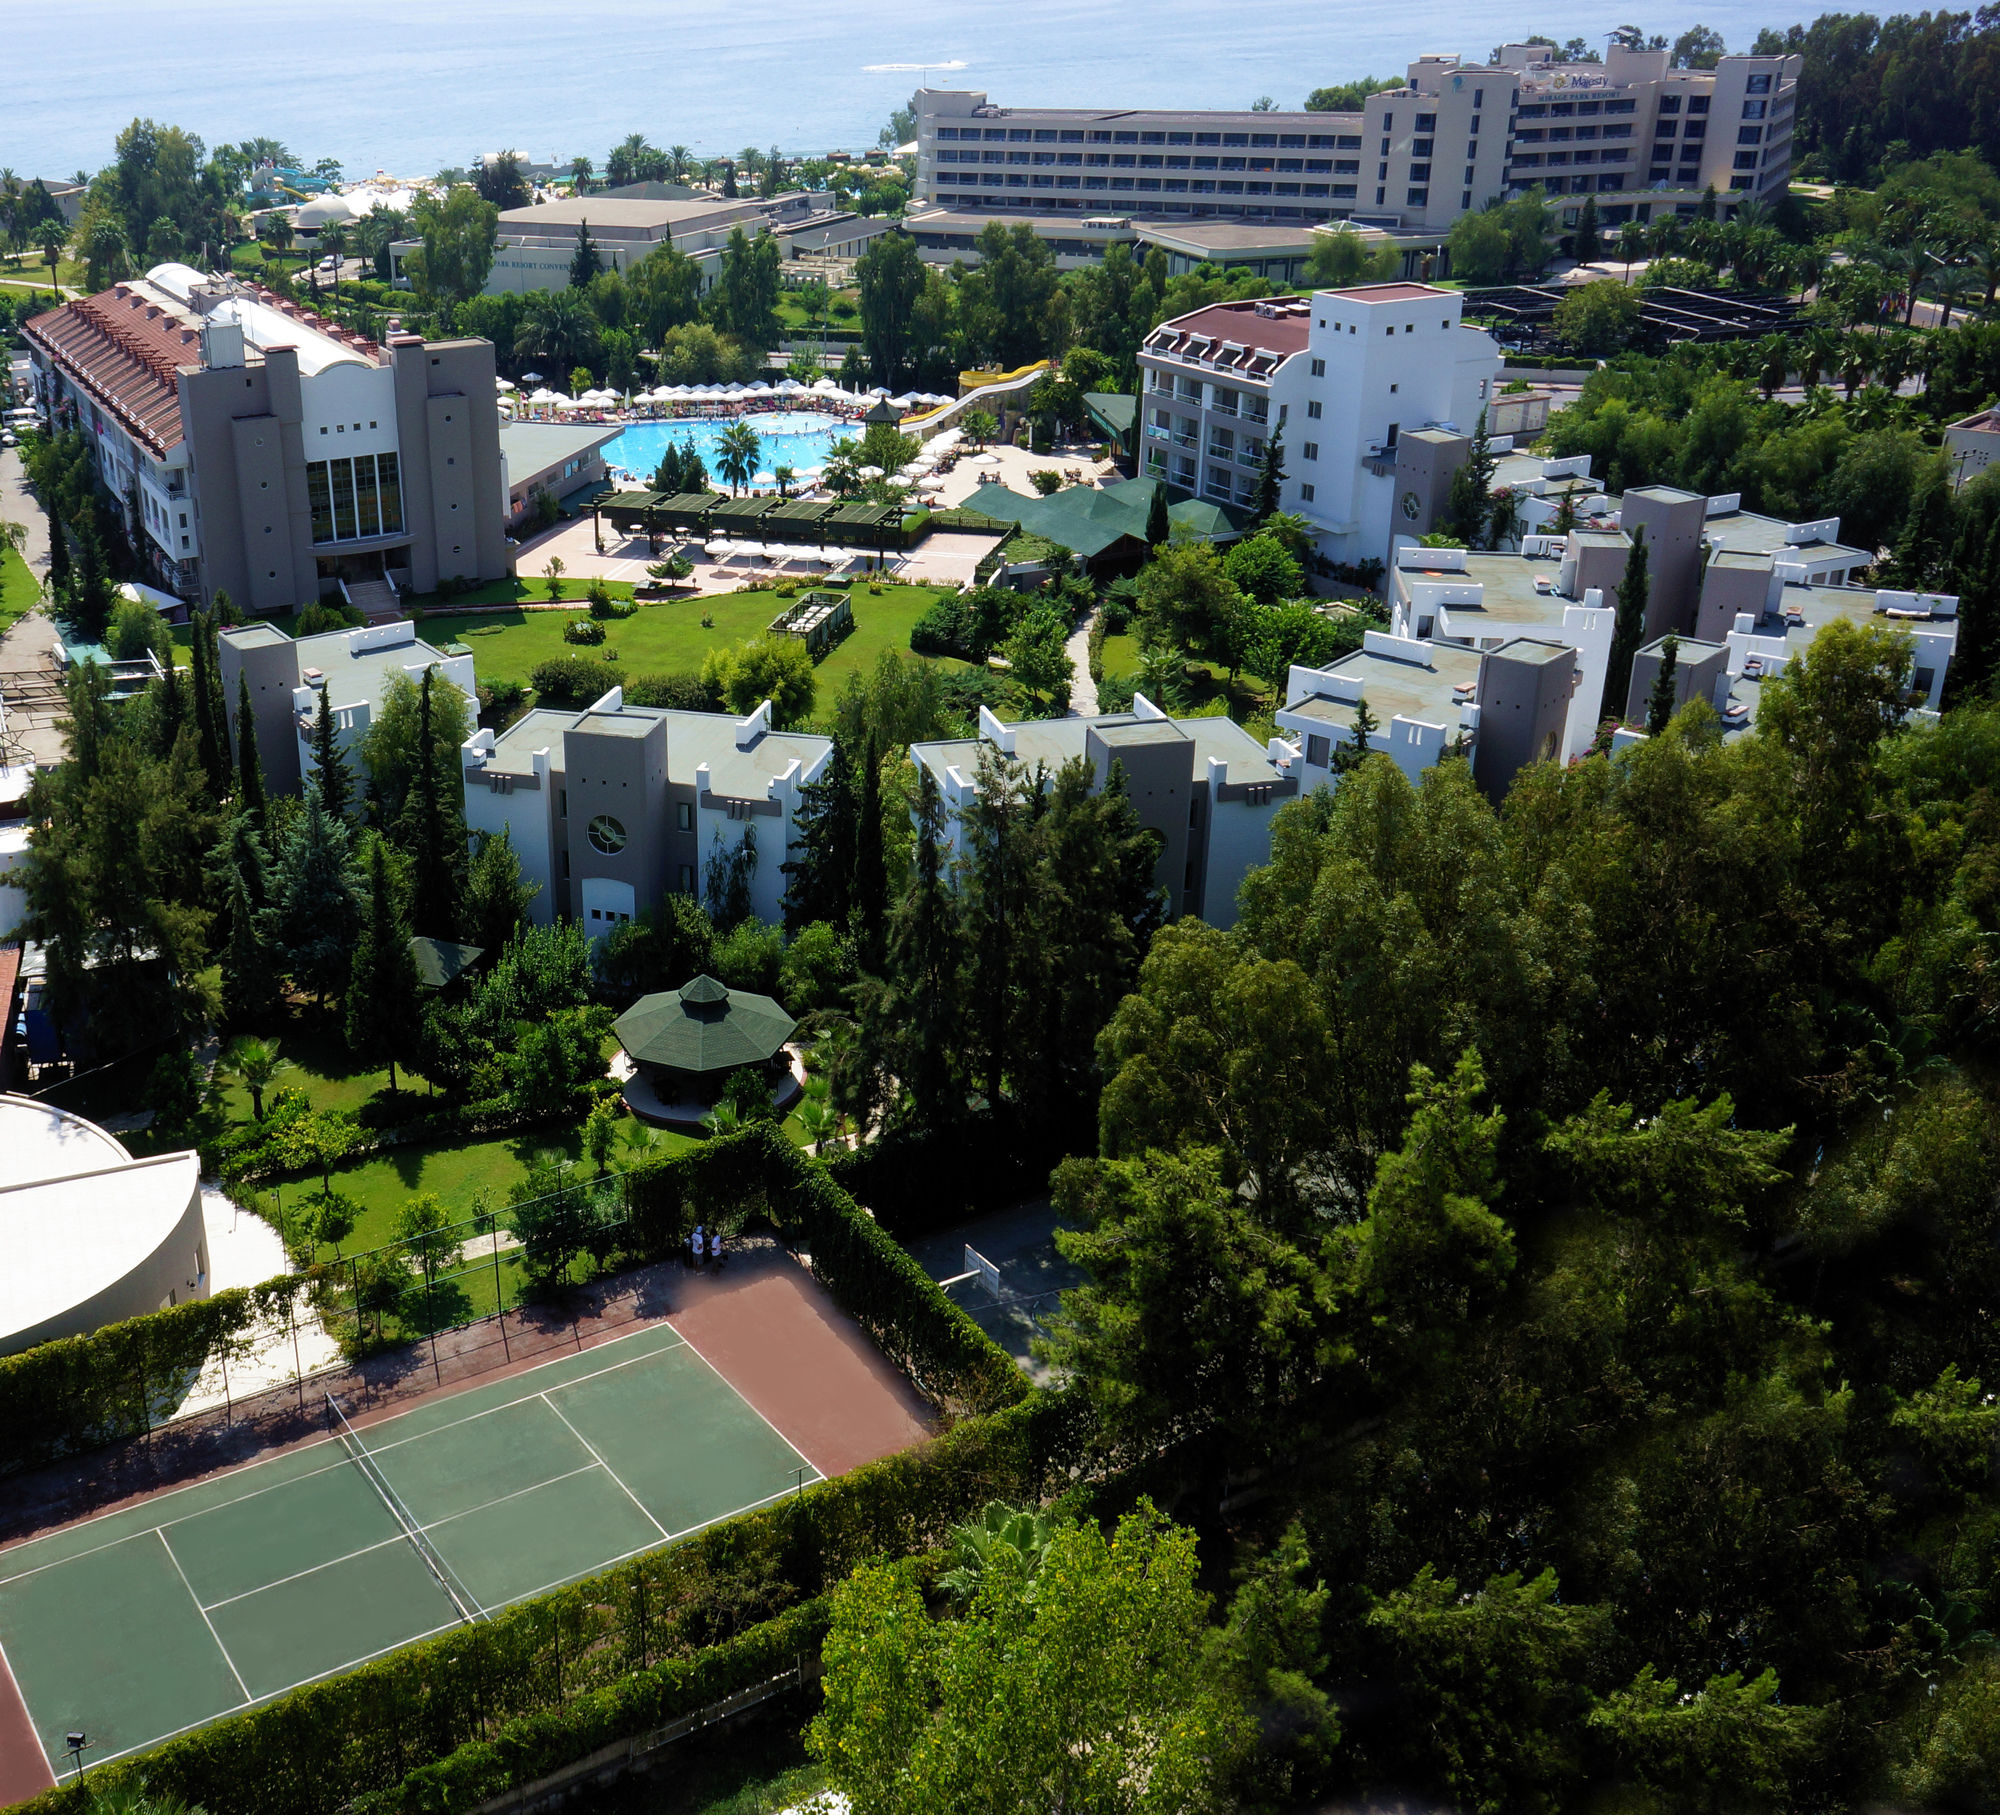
(0, 0, 1808, 178)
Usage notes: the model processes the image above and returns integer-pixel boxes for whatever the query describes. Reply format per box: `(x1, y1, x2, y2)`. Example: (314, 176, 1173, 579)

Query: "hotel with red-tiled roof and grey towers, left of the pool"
(22, 264, 510, 616)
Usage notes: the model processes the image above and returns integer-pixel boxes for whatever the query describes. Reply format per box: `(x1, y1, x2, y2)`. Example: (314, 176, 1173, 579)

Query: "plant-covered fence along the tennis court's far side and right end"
(0, 1123, 1026, 1475)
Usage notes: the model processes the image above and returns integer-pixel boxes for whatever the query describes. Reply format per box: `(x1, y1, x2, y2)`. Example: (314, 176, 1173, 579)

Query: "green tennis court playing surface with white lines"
(0, 1325, 818, 1763)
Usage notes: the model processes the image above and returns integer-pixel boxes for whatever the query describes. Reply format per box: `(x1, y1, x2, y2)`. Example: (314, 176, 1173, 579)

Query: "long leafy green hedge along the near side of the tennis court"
(11, 1391, 1092, 1815)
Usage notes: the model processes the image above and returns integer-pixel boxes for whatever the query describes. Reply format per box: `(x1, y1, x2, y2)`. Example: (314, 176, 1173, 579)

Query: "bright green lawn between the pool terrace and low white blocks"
(422, 586, 966, 712)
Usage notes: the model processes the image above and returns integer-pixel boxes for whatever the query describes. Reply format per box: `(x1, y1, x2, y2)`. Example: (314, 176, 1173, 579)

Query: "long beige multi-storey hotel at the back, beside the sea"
(908, 44, 1800, 276)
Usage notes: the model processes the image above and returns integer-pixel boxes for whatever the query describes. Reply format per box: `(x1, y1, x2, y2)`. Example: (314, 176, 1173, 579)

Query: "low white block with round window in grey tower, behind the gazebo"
(462, 688, 834, 939)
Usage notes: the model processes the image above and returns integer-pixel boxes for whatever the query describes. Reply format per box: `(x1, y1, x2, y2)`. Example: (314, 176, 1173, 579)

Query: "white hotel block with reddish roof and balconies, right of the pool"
(1138, 284, 1500, 564)
